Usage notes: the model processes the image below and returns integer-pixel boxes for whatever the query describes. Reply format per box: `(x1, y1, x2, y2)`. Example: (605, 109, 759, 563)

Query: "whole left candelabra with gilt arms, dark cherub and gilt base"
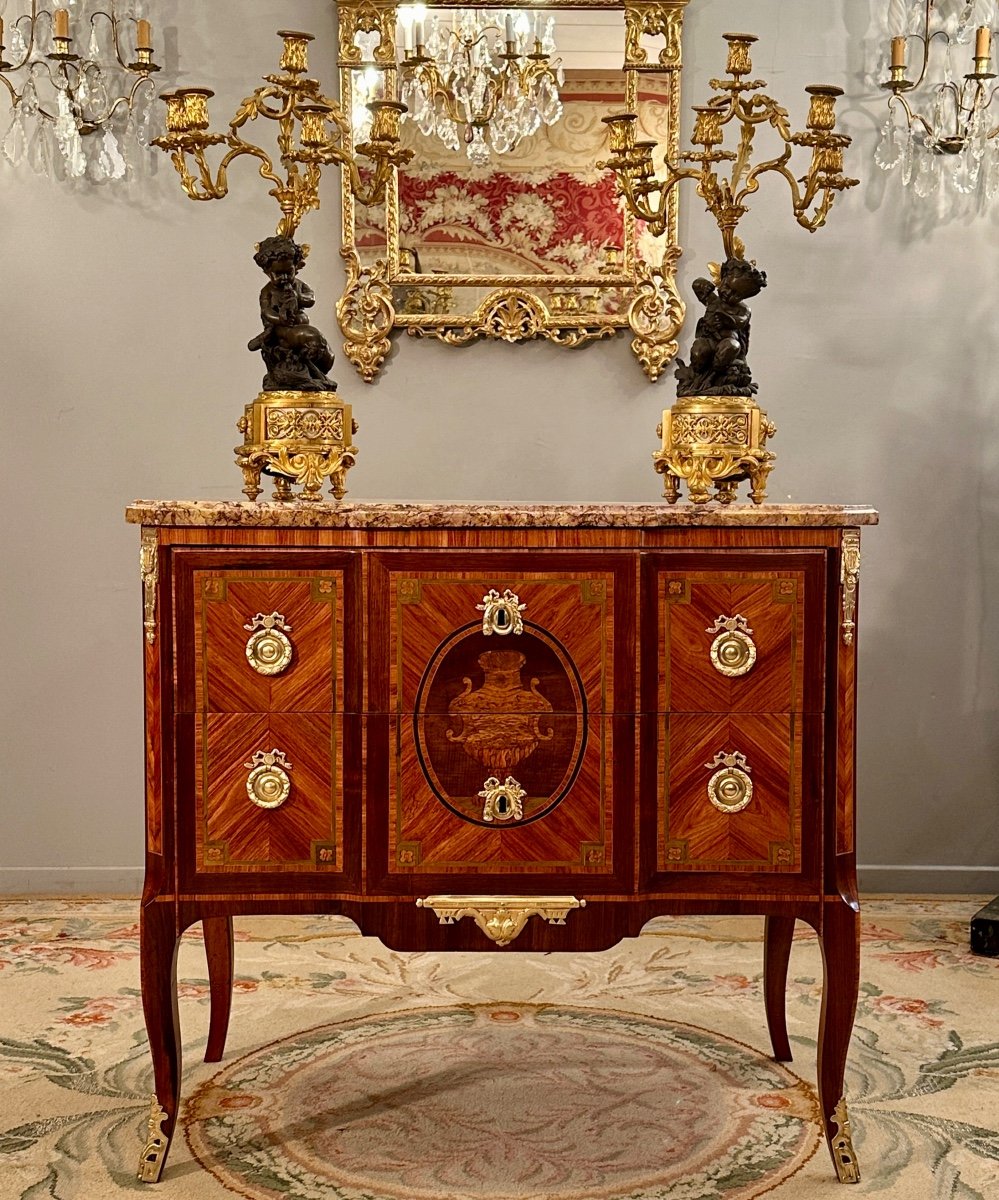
(154, 30, 412, 500)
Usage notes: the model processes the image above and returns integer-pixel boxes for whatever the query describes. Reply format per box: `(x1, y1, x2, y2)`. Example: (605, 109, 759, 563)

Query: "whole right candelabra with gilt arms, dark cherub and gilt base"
(599, 34, 857, 504)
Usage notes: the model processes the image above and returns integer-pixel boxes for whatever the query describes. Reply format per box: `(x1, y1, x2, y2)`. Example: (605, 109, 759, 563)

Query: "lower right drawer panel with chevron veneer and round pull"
(657, 713, 803, 874)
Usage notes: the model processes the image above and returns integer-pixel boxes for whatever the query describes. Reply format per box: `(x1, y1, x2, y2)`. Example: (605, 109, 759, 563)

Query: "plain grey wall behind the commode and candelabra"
(0, 0, 999, 892)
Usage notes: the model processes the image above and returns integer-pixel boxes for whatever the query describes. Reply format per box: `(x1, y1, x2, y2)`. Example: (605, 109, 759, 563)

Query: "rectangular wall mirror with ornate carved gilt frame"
(337, 0, 689, 382)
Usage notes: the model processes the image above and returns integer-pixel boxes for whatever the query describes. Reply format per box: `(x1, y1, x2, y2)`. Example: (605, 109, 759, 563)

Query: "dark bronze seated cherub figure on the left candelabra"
(249, 236, 336, 391)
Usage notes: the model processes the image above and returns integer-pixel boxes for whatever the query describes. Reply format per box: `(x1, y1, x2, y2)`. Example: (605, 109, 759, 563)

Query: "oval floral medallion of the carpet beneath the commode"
(185, 1004, 819, 1200)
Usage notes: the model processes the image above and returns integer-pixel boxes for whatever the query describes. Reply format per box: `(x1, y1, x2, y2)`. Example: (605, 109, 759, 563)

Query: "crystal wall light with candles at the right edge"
(874, 0, 999, 200)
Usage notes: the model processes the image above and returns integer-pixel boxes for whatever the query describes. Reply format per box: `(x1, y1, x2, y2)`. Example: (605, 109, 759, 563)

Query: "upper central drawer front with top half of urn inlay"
(369, 552, 635, 724)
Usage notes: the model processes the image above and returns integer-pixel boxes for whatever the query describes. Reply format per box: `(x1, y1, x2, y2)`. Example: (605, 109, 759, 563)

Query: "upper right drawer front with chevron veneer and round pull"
(642, 551, 826, 713)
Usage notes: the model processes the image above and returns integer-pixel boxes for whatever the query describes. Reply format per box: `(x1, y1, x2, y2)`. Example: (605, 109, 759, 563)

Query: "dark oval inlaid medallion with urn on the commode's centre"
(413, 622, 587, 829)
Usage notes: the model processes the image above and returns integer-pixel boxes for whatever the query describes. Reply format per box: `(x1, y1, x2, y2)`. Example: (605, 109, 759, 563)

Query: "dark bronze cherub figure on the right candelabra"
(676, 258, 766, 396)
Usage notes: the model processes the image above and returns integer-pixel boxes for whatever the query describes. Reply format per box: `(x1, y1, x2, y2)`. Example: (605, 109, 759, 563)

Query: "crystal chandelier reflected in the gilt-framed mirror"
(399, 5, 564, 164)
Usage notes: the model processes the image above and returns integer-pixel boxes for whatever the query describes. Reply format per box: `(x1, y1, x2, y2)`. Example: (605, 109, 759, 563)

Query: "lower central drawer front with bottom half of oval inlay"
(366, 713, 634, 892)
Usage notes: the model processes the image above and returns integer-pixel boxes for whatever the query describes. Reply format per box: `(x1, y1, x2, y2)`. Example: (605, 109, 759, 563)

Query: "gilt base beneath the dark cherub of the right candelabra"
(652, 396, 777, 504)
